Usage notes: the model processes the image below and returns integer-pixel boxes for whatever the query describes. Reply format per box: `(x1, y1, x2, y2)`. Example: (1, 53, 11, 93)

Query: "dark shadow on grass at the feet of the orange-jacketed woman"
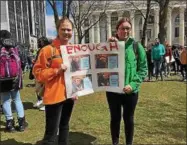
(35, 132, 97, 145)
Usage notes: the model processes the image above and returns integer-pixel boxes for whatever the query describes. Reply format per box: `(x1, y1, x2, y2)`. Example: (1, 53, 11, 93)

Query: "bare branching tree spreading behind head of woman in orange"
(47, 0, 110, 43)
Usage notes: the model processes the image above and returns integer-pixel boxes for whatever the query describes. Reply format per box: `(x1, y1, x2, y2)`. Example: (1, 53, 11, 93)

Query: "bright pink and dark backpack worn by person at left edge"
(0, 40, 20, 80)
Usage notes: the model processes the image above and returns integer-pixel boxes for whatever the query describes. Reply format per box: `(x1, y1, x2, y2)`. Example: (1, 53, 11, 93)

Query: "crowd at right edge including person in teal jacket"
(146, 38, 187, 82)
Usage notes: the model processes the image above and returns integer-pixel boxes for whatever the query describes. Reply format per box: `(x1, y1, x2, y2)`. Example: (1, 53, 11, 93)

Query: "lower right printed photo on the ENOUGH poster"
(97, 72, 119, 87)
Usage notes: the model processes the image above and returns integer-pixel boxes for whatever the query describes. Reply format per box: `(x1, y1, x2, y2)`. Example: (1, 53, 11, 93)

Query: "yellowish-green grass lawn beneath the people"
(0, 76, 186, 145)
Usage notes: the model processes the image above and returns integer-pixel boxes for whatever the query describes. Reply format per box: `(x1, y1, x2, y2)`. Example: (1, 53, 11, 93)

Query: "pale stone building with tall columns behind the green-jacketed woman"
(75, 1, 187, 45)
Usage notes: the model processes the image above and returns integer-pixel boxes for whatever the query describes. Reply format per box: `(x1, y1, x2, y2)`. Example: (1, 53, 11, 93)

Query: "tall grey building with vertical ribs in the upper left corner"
(0, 0, 46, 48)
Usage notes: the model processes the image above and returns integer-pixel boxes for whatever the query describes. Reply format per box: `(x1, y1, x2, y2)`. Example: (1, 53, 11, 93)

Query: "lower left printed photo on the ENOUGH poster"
(72, 74, 92, 94)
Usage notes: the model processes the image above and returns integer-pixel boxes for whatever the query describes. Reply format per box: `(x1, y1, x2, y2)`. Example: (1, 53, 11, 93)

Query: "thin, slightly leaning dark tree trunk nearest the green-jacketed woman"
(141, 0, 151, 47)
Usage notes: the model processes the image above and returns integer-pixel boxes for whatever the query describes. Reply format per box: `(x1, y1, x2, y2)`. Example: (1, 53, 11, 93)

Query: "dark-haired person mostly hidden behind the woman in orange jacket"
(31, 36, 51, 111)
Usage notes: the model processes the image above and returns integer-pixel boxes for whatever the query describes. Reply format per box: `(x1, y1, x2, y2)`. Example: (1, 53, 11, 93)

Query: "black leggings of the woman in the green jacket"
(106, 92, 138, 145)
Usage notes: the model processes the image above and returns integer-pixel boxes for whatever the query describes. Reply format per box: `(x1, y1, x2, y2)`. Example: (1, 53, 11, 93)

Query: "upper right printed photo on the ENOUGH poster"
(95, 54, 118, 69)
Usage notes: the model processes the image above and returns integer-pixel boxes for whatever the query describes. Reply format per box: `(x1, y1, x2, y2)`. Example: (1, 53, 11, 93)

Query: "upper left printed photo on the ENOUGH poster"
(69, 55, 91, 72)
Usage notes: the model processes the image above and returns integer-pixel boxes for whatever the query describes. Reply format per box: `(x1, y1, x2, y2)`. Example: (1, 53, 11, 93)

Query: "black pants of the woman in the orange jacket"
(42, 99, 74, 145)
